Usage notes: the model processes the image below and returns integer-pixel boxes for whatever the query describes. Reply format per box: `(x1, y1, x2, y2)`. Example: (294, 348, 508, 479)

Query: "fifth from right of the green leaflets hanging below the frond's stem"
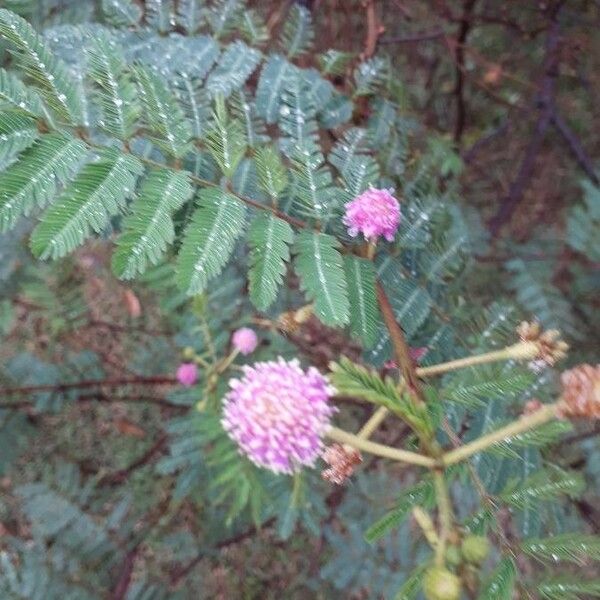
(112, 169, 193, 279)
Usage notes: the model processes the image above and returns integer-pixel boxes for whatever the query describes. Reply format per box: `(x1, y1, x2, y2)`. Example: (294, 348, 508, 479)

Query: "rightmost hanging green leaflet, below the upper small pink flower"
(344, 256, 379, 348)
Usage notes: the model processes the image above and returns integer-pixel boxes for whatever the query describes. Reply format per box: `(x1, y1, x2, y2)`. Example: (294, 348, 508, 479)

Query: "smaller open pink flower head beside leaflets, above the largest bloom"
(343, 188, 400, 242)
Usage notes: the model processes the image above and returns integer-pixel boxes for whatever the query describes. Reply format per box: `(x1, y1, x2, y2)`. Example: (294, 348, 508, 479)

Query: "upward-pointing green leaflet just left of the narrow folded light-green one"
(133, 65, 192, 158)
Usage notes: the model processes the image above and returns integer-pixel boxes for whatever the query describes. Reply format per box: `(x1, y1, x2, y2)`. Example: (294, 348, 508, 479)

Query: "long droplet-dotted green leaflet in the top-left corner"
(0, 9, 83, 124)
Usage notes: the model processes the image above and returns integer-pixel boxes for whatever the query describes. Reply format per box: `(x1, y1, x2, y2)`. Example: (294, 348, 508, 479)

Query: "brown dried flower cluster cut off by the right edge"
(559, 365, 600, 419)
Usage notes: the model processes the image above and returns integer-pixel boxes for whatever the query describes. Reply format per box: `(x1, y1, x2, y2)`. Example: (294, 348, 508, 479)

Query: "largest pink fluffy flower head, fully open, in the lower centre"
(221, 358, 336, 474)
